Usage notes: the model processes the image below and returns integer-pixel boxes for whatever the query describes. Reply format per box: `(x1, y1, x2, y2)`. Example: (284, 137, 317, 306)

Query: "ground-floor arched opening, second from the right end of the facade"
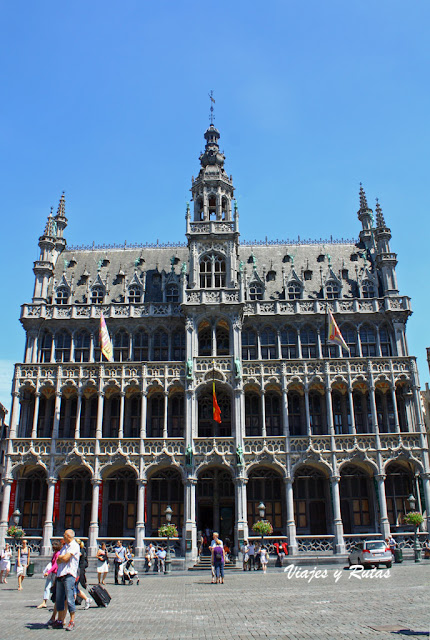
(339, 464, 370, 533)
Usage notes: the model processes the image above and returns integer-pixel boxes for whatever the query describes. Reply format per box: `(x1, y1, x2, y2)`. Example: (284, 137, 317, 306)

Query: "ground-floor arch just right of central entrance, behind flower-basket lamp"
(246, 467, 285, 536)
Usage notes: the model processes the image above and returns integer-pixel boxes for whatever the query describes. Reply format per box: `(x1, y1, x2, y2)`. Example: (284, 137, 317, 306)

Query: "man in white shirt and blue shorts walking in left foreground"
(52, 529, 81, 631)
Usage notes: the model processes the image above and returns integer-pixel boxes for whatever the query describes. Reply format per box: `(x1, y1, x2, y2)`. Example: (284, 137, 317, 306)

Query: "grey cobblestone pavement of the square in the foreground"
(0, 562, 430, 640)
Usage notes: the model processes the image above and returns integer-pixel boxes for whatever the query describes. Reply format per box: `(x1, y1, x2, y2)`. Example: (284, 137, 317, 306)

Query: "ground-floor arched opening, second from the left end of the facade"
(61, 470, 92, 536)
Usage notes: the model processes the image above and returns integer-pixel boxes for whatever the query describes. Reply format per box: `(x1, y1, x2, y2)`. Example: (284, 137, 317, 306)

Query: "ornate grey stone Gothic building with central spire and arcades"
(0, 124, 430, 560)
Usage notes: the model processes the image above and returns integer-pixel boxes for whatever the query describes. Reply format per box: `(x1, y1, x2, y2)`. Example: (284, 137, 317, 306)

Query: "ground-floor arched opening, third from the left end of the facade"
(104, 469, 137, 537)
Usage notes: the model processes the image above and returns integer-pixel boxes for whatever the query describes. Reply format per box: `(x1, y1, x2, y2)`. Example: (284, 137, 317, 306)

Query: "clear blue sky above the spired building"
(0, 0, 430, 408)
